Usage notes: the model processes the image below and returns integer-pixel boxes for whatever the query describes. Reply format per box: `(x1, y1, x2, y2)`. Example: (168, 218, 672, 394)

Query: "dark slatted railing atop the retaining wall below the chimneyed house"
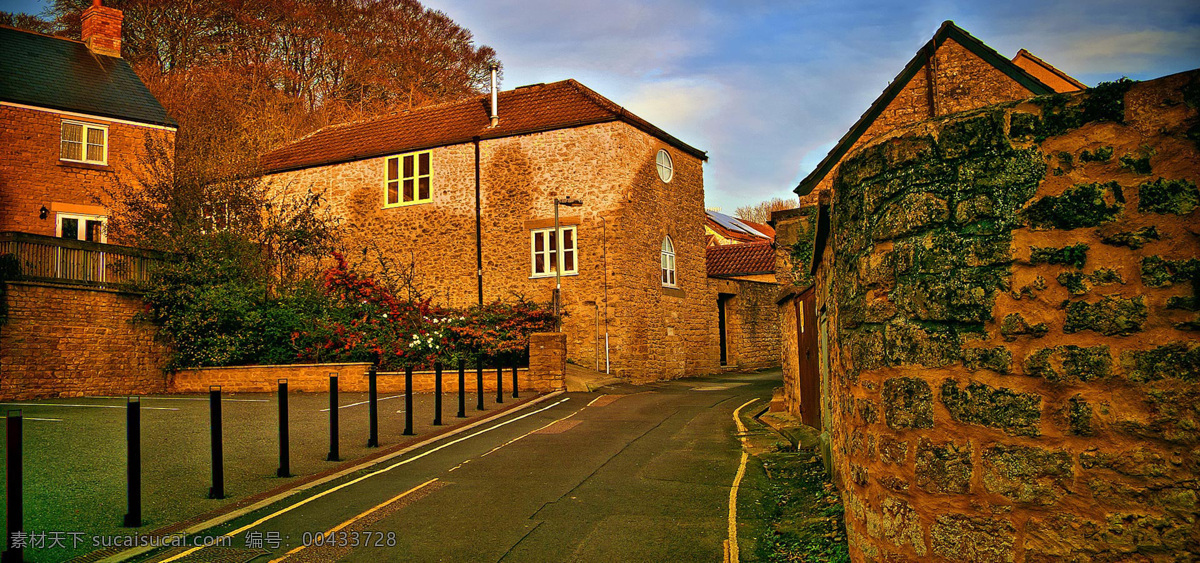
(0, 232, 168, 288)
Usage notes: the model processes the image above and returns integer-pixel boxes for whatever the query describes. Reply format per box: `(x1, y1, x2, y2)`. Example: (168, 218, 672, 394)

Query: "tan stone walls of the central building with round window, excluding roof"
(270, 122, 718, 381)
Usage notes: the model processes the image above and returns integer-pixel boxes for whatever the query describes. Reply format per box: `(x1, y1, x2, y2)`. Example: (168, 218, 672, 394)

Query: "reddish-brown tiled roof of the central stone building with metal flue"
(262, 80, 708, 173)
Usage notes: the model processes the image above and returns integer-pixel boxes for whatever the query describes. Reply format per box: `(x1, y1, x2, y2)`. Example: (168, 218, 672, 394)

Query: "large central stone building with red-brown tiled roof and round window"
(262, 80, 718, 381)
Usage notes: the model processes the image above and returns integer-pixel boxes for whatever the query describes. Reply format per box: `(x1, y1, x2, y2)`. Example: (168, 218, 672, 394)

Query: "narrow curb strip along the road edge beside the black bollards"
(83, 390, 566, 563)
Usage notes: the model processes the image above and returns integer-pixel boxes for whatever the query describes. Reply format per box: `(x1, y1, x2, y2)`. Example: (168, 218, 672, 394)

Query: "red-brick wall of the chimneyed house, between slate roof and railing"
(0, 103, 175, 238)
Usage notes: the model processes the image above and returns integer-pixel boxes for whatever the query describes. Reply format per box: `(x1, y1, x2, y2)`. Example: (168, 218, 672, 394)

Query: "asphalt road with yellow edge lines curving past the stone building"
(140, 371, 780, 562)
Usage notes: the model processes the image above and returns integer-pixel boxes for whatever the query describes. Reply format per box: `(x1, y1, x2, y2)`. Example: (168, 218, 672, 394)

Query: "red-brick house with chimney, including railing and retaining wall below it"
(0, 1, 176, 400)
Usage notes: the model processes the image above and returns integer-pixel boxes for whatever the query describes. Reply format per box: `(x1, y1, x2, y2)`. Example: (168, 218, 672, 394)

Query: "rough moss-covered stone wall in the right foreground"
(820, 71, 1200, 562)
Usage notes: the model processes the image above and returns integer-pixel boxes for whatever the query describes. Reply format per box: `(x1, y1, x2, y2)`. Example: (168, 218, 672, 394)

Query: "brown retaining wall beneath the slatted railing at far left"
(0, 282, 167, 401)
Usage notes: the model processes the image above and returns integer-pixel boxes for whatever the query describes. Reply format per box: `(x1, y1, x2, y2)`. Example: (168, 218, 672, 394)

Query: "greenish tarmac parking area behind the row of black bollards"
(0, 387, 533, 562)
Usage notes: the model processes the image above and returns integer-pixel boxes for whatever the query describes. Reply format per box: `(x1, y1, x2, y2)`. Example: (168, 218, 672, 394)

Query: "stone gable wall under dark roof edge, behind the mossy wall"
(800, 38, 1033, 204)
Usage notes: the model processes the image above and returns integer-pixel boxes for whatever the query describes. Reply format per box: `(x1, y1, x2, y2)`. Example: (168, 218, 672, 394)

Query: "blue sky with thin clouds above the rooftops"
(0, 0, 1200, 211)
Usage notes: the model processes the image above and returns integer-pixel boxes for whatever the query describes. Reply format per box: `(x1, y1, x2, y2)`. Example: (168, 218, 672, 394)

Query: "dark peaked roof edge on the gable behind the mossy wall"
(793, 20, 1055, 196)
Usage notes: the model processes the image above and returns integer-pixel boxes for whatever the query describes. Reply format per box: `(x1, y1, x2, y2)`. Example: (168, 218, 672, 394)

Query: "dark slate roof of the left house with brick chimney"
(0, 25, 179, 127)
